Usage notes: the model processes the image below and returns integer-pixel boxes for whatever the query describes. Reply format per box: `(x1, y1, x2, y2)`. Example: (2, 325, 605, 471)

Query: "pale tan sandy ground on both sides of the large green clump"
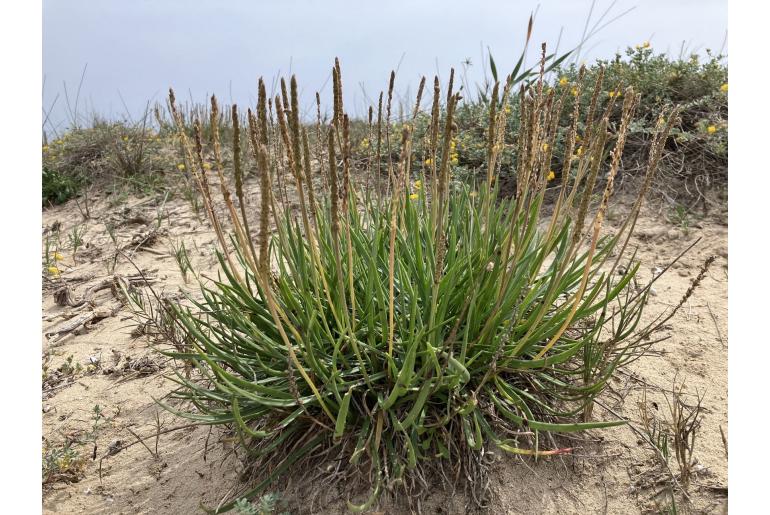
(41, 186, 727, 514)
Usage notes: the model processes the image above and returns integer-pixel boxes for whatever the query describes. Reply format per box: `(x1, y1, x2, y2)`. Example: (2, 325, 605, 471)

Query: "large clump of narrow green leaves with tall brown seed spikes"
(158, 52, 676, 511)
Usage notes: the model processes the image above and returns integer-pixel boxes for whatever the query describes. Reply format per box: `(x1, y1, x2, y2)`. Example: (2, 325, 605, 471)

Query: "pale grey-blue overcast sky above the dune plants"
(43, 0, 727, 131)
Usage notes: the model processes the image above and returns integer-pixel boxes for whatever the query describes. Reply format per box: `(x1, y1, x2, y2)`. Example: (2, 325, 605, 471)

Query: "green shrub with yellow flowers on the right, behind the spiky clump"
(374, 44, 728, 204)
